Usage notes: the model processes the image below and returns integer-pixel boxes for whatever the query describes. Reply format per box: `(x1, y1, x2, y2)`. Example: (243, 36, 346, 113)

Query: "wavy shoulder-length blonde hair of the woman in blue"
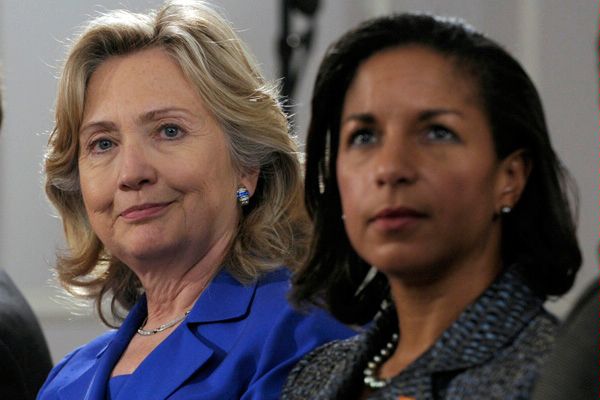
(45, 1, 307, 326)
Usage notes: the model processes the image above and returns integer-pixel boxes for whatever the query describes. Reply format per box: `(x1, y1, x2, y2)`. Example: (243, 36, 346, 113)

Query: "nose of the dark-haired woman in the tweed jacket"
(375, 131, 418, 186)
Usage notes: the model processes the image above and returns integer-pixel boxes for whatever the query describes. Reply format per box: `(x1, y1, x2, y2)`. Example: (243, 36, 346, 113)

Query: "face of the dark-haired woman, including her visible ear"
(337, 46, 516, 276)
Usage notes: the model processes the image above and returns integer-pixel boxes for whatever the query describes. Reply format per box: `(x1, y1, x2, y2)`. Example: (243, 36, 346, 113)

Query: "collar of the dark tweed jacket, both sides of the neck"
(284, 269, 543, 400)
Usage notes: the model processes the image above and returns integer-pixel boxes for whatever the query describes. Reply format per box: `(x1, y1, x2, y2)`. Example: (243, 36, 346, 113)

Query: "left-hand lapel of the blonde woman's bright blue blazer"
(59, 297, 146, 400)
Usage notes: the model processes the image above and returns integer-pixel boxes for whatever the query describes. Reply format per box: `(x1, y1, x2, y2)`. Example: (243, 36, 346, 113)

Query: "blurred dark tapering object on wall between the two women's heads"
(279, 0, 319, 108)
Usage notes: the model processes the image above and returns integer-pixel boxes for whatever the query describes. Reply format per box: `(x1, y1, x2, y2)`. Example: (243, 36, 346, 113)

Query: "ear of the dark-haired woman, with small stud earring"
(495, 149, 531, 214)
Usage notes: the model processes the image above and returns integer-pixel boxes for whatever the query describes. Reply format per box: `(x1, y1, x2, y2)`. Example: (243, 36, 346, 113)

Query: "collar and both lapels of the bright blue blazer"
(59, 269, 256, 400)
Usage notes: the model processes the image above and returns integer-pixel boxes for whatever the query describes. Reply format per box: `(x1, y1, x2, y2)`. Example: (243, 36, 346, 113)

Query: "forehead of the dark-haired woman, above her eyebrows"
(344, 45, 481, 116)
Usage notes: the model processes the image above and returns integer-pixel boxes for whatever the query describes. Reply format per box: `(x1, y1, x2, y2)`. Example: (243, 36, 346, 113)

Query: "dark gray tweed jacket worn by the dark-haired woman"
(282, 271, 557, 400)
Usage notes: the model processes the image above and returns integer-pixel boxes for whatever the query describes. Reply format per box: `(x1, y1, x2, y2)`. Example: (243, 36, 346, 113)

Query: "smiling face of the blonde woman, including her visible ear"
(79, 48, 256, 265)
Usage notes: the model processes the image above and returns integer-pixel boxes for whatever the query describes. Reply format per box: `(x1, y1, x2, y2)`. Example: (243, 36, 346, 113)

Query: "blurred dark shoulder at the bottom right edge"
(532, 279, 600, 400)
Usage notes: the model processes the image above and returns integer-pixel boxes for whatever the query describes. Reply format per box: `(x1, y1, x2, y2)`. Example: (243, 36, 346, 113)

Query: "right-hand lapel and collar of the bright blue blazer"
(118, 270, 256, 400)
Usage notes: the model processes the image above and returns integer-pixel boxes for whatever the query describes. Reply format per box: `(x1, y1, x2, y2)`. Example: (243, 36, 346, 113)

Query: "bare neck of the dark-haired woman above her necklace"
(380, 252, 501, 377)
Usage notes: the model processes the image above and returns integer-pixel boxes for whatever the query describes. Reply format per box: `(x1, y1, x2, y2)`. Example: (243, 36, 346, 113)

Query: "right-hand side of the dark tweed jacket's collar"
(365, 270, 543, 400)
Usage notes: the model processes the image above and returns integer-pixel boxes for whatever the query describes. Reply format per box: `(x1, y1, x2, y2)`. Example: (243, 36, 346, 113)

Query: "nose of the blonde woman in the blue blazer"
(119, 143, 157, 191)
